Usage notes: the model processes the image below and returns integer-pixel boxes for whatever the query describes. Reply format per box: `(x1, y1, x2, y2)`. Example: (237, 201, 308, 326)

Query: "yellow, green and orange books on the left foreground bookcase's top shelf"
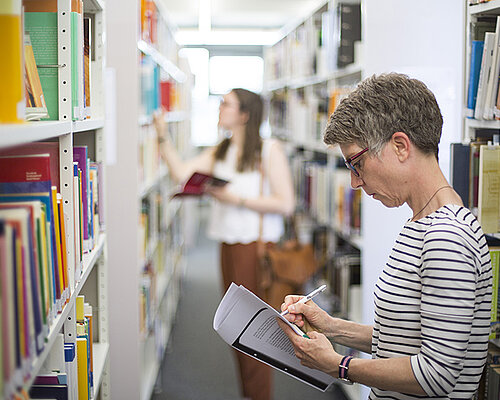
(0, 0, 93, 123)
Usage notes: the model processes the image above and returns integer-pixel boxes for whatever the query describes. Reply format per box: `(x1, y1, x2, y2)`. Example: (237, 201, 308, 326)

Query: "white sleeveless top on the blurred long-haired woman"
(207, 139, 283, 244)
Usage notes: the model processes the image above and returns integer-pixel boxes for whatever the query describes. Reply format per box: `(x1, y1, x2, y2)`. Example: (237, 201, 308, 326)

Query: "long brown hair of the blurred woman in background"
(214, 88, 264, 172)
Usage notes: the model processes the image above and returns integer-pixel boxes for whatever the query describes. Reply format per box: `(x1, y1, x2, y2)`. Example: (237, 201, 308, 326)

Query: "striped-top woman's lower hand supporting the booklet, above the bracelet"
(278, 319, 342, 377)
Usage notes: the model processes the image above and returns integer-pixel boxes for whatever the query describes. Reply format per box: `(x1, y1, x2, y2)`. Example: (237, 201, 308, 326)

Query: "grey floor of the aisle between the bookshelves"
(152, 207, 346, 400)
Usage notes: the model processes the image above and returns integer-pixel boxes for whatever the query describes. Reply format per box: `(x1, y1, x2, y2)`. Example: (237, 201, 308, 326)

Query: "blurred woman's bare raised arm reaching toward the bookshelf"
(154, 113, 215, 183)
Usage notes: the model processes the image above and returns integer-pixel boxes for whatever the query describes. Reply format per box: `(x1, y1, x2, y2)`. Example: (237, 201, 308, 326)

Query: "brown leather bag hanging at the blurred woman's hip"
(260, 239, 319, 310)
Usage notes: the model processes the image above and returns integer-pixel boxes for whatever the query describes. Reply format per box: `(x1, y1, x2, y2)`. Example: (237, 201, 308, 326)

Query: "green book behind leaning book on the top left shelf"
(24, 12, 59, 120)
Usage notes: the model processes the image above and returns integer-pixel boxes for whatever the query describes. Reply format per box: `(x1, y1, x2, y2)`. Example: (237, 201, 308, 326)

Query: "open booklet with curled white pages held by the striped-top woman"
(214, 283, 337, 391)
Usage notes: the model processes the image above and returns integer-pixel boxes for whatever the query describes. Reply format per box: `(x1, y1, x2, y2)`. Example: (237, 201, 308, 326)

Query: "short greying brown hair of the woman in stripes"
(323, 73, 443, 158)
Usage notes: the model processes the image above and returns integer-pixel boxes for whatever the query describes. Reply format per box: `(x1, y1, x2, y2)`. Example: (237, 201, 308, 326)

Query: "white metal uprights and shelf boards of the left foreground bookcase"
(0, 0, 109, 400)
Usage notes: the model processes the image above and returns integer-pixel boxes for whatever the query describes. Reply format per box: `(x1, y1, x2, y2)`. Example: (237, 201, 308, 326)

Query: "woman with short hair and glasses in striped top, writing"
(279, 73, 492, 399)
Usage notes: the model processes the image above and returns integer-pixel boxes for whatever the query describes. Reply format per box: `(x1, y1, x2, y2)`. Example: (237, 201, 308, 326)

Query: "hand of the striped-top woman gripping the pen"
(281, 295, 330, 333)
